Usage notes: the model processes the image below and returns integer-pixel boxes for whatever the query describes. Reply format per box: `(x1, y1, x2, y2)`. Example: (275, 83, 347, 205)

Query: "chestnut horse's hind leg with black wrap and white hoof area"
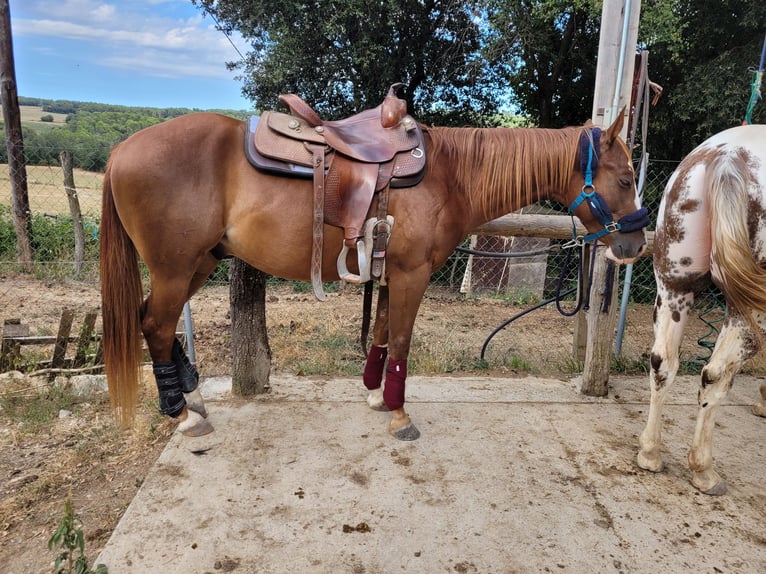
(141, 277, 213, 436)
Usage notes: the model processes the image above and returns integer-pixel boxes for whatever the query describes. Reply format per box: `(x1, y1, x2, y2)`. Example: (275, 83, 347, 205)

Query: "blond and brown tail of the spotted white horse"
(705, 155, 766, 337)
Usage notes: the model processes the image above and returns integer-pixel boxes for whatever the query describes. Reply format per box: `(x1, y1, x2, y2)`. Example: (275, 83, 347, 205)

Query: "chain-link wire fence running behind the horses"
(0, 144, 728, 374)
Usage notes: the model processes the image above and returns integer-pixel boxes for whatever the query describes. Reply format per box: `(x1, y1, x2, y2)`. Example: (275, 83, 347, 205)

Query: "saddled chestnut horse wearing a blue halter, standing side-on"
(101, 113, 648, 440)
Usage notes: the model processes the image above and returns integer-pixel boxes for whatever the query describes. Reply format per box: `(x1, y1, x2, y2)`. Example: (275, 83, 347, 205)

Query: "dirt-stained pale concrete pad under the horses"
(97, 376, 766, 574)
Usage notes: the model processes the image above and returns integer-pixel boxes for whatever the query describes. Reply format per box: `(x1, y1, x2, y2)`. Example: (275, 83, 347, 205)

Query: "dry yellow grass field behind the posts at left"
(0, 164, 104, 217)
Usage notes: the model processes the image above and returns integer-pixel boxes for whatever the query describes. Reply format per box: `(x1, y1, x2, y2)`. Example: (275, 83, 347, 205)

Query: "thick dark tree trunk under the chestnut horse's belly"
(229, 259, 271, 397)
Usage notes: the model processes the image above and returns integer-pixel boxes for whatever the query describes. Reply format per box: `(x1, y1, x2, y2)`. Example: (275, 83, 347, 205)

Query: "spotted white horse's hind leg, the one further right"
(689, 315, 758, 496)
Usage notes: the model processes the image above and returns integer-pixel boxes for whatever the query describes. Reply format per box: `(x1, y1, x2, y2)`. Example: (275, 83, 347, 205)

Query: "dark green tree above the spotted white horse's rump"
(639, 0, 766, 159)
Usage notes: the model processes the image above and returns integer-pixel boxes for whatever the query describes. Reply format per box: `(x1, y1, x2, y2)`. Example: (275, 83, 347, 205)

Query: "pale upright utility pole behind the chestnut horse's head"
(580, 0, 641, 396)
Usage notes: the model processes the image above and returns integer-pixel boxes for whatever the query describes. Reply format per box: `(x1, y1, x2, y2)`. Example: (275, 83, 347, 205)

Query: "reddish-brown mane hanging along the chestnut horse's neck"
(427, 127, 583, 219)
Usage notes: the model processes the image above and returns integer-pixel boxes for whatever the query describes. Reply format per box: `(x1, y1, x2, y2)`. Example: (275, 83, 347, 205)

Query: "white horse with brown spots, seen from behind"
(638, 125, 766, 495)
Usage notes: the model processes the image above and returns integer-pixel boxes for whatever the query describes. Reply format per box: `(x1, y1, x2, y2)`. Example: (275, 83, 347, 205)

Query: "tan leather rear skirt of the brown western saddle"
(253, 112, 330, 167)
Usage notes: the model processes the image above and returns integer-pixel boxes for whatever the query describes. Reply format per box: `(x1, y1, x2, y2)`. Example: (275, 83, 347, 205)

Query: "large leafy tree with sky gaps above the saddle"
(192, 0, 501, 123)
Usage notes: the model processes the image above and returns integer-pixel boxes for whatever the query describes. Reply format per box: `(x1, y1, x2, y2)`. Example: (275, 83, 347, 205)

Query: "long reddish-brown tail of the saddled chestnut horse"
(100, 149, 143, 428)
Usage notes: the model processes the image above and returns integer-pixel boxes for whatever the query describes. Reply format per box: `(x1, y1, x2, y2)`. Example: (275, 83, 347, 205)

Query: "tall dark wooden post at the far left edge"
(0, 0, 32, 272)
